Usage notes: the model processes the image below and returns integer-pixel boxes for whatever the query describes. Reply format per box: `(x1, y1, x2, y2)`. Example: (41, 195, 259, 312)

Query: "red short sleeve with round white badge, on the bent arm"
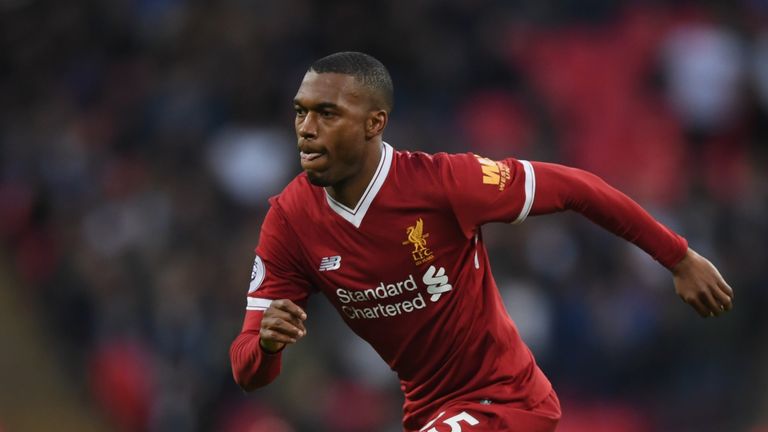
(246, 207, 311, 311)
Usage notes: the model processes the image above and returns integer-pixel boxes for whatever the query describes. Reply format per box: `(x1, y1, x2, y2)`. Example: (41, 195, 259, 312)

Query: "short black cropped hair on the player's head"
(309, 51, 395, 112)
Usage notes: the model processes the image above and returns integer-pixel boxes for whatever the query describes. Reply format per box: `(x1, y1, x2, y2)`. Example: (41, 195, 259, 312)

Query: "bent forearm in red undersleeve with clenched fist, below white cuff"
(229, 300, 307, 391)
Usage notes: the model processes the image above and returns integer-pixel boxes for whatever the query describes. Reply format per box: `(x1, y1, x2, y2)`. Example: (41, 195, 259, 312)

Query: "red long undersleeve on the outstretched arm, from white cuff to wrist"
(531, 162, 688, 268)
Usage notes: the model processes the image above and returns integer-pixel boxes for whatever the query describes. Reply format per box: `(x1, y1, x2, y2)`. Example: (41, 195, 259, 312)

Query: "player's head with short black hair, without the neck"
(294, 52, 393, 187)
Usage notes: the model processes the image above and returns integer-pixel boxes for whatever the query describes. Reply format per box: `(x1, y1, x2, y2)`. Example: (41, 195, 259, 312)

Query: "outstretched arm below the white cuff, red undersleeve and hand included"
(530, 162, 733, 317)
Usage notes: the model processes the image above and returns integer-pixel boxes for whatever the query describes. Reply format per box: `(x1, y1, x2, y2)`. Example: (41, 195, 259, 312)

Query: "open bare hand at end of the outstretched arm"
(671, 249, 733, 318)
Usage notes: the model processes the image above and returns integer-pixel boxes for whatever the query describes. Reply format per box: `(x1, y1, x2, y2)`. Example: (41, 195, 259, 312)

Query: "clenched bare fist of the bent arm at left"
(259, 300, 307, 353)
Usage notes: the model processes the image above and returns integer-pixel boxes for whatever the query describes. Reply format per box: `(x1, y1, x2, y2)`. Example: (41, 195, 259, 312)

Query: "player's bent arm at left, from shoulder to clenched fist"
(229, 203, 311, 391)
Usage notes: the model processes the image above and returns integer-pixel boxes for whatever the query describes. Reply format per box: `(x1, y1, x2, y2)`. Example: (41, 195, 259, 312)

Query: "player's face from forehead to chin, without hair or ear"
(294, 72, 370, 186)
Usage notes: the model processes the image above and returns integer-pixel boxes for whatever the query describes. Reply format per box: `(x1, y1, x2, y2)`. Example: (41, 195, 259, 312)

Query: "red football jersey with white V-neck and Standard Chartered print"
(245, 144, 551, 429)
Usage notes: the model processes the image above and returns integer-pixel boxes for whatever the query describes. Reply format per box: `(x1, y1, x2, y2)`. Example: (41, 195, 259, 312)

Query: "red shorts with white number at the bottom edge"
(413, 390, 560, 432)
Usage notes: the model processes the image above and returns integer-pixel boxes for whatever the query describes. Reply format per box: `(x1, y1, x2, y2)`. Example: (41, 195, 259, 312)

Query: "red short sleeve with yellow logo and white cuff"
(440, 153, 536, 237)
